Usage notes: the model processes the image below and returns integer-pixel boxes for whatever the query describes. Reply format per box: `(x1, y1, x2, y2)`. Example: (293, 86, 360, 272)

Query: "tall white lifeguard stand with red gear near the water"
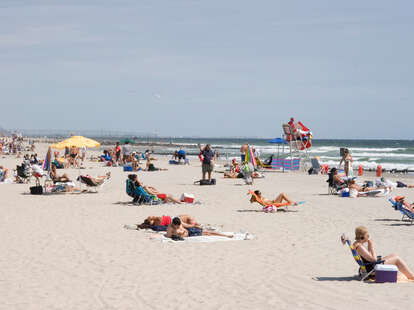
(282, 124, 311, 171)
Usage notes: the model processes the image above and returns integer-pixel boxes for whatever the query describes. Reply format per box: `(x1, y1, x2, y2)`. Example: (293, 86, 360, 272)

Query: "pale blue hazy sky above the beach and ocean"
(0, 0, 414, 139)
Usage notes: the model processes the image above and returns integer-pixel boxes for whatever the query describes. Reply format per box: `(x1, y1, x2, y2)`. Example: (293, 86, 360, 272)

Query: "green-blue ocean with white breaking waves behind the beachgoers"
(125, 138, 414, 170)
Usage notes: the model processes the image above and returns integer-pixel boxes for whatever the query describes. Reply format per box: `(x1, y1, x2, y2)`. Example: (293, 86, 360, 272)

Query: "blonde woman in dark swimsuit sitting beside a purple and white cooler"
(354, 226, 414, 280)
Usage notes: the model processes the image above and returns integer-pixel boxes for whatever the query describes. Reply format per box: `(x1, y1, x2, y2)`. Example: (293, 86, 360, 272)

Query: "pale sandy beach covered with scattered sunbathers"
(0, 147, 414, 310)
